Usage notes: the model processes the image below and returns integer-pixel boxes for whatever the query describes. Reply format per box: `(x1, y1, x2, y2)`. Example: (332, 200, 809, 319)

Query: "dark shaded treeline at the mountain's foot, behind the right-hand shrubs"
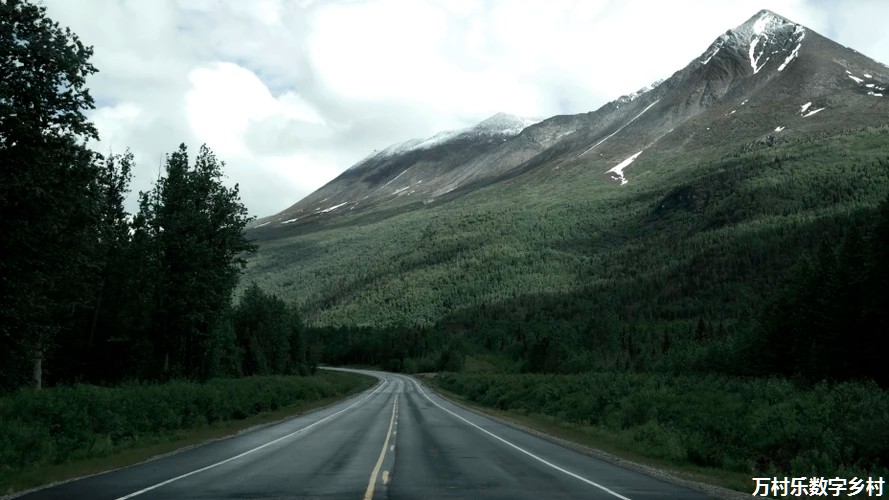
(298, 188, 889, 386)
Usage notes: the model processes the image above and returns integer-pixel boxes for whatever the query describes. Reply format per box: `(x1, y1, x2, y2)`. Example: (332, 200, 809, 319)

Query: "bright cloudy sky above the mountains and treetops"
(42, 0, 889, 217)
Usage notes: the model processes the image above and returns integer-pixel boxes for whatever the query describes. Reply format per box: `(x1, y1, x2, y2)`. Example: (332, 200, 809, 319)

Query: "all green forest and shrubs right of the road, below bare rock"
(258, 127, 889, 492)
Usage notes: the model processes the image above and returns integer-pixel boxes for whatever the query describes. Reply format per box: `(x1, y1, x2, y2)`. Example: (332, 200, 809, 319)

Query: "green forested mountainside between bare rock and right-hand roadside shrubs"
(246, 126, 889, 382)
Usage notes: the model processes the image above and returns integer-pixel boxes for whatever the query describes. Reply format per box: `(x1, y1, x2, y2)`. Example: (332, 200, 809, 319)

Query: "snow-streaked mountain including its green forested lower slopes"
(245, 10, 889, 331)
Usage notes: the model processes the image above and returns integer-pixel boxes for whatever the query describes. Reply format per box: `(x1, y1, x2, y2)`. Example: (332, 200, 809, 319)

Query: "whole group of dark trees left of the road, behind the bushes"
(0, 1, 306, 390)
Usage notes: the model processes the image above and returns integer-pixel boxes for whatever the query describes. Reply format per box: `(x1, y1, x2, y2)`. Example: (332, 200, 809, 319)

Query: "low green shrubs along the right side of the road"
(434, 372, 889, 477)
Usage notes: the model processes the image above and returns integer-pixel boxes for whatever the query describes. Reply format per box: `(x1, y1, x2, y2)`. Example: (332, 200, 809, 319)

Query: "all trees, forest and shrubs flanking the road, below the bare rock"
(0, 2, 889, 491)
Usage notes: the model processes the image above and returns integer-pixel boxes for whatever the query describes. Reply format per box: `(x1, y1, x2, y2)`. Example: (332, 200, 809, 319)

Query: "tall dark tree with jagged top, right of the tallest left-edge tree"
(136, 144, 255, 377)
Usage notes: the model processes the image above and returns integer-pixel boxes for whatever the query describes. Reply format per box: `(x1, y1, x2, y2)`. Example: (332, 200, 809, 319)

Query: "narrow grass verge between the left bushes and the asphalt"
(0, 372, 375, 494)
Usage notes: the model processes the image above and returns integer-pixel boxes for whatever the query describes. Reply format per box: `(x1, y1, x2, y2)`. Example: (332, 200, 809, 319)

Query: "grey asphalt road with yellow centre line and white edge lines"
(22, 372, 720, 500)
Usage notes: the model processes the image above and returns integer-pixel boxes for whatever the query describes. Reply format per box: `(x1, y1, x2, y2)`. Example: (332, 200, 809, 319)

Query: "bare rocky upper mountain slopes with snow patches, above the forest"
(255, 10, 889, 234)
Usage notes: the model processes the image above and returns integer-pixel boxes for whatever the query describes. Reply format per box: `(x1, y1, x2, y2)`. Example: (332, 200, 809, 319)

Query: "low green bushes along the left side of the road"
(0, 373, 369, 483)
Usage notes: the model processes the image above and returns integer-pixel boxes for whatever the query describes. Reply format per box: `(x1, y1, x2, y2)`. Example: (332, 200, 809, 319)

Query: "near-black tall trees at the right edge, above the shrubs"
(747, 198, 889, 387)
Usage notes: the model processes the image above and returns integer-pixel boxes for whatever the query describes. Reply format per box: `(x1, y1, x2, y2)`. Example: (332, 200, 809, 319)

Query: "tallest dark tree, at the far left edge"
(0, 0, 98, 388)
